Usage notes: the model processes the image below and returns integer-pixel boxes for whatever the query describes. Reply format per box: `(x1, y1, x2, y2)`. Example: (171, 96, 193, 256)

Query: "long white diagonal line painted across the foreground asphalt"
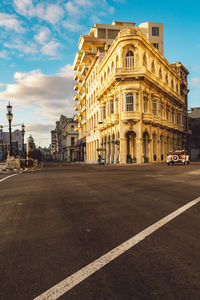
(33, 197, 200, 300)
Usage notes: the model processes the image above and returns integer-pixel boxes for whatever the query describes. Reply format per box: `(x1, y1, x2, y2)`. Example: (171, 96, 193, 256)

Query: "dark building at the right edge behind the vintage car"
(188, 107, 200, 160)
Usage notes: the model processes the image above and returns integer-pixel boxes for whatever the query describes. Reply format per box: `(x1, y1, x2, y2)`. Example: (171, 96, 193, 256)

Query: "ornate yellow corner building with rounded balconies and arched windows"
(74, 21, 188, 163)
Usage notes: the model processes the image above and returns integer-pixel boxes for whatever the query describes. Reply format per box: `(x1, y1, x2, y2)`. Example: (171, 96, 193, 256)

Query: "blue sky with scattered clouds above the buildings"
(0, 0, 200, 146)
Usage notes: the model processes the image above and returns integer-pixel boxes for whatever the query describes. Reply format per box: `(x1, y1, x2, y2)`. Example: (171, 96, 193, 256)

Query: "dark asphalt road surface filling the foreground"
(0, 163, 200, 300)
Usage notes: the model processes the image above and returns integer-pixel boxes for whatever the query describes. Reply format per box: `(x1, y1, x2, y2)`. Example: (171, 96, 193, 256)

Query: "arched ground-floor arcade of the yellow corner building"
(86, 125, 186, 164)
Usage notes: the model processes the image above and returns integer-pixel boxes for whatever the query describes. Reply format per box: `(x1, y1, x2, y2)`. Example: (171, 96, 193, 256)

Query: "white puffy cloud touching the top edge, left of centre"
(14, 0, 64, 24)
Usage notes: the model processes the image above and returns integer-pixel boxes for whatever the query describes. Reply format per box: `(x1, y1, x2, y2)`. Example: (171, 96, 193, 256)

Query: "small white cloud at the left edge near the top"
(0, 13, 25, 32)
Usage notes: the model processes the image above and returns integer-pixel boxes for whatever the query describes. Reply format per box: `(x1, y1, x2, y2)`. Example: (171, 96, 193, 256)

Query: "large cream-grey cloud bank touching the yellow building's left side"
(0, 65, 75, 122)
